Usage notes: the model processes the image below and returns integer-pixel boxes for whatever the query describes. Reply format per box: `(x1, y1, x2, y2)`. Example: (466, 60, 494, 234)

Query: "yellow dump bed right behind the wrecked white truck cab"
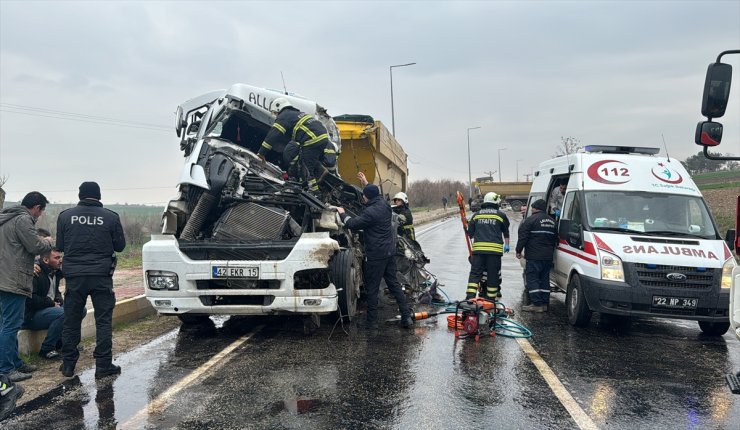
(334, 115, 408, 197)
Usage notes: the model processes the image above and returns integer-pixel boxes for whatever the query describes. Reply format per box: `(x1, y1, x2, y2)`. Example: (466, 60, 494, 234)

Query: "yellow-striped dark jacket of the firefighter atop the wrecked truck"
(259, 108, 329, 155)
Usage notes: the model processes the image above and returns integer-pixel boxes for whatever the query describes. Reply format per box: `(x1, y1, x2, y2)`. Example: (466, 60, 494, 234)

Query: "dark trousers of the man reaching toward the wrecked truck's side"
(363, 256, 411, 326)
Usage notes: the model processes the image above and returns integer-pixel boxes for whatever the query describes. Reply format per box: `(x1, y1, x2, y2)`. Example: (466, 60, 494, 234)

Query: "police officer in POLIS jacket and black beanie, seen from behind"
(56, 182, 126, 379)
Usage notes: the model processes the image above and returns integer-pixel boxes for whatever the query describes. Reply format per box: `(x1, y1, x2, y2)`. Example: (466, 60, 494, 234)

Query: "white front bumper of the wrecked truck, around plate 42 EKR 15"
(142, 233, 339, 315)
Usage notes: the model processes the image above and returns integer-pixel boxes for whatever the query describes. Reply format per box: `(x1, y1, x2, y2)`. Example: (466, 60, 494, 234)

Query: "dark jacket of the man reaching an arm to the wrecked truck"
(342, 196, 396, 260)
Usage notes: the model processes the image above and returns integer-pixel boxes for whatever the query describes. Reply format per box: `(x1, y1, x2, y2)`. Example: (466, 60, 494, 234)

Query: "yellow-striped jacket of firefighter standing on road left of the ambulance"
(468, 203, 509, 255)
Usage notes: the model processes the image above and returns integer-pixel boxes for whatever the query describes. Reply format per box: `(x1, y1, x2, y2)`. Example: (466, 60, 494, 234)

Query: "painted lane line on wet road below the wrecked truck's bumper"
(121, 325, 264, 429)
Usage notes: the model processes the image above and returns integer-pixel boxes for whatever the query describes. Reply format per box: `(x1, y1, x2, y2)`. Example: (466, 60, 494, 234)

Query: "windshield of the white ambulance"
(583, 191, 720, 240)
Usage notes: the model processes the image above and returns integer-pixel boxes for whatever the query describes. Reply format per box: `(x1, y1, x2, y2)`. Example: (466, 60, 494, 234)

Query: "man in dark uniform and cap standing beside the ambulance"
(516, 199, 558, 312)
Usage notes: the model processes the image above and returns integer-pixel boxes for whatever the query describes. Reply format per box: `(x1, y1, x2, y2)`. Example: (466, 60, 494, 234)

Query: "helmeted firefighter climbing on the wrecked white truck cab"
(257, 97, 329, 193)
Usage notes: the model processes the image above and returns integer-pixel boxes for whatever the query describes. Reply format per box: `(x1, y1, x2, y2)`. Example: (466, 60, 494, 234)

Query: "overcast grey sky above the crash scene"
(0, 0, 740, 204)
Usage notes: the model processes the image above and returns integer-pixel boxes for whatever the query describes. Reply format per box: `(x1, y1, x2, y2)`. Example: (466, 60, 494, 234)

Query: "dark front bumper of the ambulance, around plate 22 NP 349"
(581, 276, 729, 322)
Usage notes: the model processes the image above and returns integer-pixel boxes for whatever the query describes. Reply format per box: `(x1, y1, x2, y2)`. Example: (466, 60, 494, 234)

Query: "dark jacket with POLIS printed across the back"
(56, 199, 126, 278)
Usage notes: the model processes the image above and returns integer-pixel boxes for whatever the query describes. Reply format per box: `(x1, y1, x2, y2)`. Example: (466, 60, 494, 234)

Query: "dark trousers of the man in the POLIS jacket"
(62, 276, 116, 367)
